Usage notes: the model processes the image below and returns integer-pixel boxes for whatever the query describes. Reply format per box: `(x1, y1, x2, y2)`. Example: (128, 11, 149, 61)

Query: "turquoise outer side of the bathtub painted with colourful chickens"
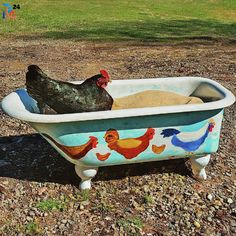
(31, 110, 223, 166)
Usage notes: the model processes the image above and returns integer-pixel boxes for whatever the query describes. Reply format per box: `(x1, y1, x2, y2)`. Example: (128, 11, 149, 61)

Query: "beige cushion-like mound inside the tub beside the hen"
(112, 90, 203, 110)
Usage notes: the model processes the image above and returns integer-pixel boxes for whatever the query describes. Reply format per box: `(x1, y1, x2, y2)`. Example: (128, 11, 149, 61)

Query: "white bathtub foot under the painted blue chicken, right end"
(190, 154, 210, 180)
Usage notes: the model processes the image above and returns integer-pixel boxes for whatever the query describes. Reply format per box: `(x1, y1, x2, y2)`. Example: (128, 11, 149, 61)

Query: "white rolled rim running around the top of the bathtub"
(1, 77, 235, 123)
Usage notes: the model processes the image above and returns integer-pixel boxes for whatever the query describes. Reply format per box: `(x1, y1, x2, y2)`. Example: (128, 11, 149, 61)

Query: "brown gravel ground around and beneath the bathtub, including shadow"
(0, 39, 236, 236)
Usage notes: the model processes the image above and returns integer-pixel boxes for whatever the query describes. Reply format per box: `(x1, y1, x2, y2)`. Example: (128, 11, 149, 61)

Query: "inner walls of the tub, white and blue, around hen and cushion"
(11, 78, 225, 113)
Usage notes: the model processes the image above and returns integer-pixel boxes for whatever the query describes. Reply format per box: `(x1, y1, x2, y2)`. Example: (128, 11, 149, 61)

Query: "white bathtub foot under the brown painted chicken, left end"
(75, 165, 98, 190)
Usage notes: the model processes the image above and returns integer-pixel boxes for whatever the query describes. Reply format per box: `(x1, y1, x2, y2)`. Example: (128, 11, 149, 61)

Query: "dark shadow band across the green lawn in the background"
(22, 19, 236, 41)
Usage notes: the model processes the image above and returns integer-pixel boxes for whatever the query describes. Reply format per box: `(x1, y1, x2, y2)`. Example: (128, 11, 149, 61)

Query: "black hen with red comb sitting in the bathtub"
(26, 65, 113, 114)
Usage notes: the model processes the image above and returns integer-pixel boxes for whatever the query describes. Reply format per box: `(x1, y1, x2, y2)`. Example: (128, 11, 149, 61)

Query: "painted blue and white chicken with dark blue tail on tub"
(161, 119, 215, 152)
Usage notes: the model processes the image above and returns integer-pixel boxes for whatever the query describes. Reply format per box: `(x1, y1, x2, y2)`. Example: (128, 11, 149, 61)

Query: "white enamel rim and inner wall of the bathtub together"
(1, 77, 235, 123)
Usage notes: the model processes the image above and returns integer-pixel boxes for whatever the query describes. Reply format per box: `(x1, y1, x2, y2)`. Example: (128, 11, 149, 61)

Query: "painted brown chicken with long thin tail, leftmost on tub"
(42, 133, 98, 160)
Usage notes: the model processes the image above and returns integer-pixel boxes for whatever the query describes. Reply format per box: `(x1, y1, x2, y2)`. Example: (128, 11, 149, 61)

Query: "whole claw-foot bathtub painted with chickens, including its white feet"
(1, 77, 235, 189)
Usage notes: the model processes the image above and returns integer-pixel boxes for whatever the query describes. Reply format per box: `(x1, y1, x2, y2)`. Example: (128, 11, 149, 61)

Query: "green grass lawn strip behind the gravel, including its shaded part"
(0, 0, 236, 41)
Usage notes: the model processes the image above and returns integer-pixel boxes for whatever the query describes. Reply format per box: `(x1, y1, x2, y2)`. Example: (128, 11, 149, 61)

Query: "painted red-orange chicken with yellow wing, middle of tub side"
(104, 128, 155, 159)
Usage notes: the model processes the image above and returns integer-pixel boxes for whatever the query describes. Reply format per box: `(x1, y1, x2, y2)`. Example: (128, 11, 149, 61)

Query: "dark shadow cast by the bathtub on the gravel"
(0, 134, 190, 186)
